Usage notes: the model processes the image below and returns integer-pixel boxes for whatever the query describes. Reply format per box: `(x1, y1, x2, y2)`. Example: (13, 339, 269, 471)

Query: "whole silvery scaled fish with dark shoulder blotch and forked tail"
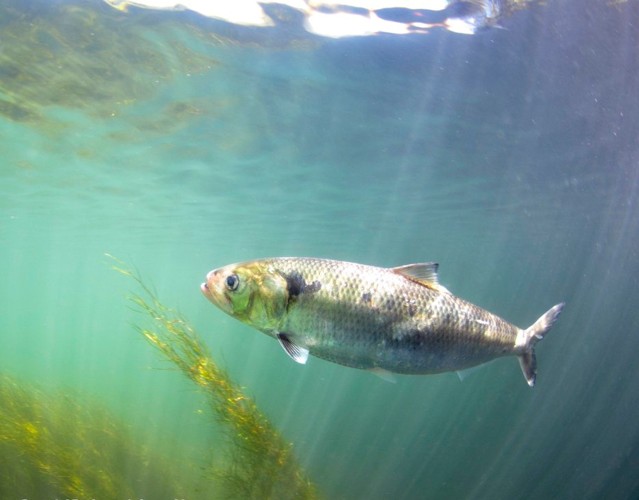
(200, 257, 565, 387)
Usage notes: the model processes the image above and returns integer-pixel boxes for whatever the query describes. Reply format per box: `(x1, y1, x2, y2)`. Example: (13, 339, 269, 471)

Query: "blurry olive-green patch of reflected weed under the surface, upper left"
(0, 0, 217, 124)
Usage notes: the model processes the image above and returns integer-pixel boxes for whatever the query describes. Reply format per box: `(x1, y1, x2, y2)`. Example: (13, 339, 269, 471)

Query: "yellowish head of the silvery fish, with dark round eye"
(200, 261, 288, 334)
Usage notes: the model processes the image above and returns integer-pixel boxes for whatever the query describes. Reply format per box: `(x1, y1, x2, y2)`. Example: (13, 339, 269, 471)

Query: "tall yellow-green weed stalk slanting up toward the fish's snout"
(114, 263, 318, 499)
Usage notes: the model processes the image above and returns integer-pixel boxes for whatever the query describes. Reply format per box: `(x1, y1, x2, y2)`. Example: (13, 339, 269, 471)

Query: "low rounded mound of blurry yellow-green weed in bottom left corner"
(0, 375, 183, 498)
